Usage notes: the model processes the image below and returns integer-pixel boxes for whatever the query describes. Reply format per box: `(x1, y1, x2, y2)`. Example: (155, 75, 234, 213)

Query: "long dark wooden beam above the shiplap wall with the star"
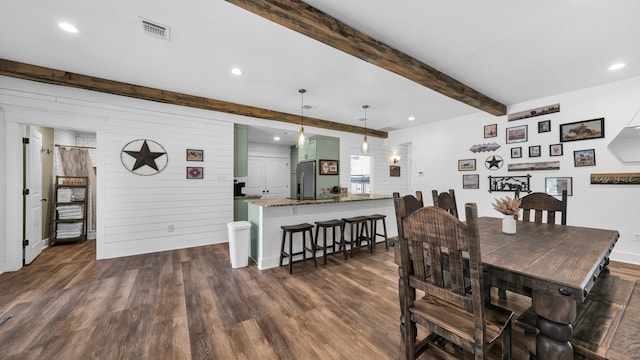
(0, 59, 388, 139)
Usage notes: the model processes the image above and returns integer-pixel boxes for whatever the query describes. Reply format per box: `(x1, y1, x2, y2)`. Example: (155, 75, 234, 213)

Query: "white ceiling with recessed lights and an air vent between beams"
(0, 0, 640, 145)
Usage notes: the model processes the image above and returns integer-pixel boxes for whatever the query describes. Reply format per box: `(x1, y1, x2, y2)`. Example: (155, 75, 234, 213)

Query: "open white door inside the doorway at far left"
(24, 126, 44, 265)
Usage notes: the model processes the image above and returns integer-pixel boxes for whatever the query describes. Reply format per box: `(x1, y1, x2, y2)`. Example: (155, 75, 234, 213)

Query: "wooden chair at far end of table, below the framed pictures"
(516, 190, 567, 225)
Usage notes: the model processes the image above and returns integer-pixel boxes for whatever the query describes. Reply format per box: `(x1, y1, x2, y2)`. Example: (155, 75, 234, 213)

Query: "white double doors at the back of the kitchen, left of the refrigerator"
(244, 157, 291, 199)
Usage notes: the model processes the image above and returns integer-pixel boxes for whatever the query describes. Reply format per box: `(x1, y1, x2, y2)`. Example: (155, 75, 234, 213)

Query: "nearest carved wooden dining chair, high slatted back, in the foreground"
(399, 204, 513, 359)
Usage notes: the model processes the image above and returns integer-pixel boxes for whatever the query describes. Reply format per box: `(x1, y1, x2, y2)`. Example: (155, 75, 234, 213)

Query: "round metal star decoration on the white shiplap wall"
(120, 139, 169, 176)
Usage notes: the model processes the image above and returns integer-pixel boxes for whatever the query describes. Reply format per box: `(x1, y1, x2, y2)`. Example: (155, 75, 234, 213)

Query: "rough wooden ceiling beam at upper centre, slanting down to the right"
(226, 0, 507, 116)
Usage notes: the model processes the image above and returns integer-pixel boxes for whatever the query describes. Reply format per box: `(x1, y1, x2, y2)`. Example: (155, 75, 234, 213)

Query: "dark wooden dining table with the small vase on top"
(390, 217, 619, 360)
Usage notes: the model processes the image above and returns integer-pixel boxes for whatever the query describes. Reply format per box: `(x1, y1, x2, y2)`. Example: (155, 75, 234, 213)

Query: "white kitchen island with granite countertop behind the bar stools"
(247, 194, 398, 270)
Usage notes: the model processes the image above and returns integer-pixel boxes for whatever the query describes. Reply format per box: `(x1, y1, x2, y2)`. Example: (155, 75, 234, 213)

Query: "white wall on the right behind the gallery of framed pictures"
(389, 78, 640, 264)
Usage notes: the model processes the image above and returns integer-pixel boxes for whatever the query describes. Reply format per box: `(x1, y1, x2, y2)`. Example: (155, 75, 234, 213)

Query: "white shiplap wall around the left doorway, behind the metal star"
(0, 77, 233, 272)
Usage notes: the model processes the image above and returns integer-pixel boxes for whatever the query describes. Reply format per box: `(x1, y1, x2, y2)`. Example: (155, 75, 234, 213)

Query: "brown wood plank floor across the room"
(0, 241, 640, 359)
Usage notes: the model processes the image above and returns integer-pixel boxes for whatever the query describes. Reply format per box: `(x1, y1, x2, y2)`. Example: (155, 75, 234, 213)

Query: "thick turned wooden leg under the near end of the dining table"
(532, 290, 577, 360)
